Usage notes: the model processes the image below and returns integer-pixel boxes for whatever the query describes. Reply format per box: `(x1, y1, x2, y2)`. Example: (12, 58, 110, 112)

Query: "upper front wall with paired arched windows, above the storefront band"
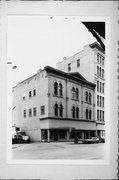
(48, 70, 95, 120)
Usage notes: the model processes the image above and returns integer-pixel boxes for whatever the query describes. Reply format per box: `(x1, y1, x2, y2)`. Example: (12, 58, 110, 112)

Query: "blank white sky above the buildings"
(7, 15, 96, 86)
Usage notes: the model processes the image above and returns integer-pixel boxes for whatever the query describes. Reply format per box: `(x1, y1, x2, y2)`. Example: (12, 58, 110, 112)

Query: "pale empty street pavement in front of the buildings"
(12, 142, 105, 160)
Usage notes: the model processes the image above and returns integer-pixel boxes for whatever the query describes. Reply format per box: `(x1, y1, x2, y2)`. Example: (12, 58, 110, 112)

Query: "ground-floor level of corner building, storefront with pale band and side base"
(22, 118, 105, 142)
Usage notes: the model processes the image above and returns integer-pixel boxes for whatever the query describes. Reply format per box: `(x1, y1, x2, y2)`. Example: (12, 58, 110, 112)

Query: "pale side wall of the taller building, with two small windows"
(56, 45, 104, 83)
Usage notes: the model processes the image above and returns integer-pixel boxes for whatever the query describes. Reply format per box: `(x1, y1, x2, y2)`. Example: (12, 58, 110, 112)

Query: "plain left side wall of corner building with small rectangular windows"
(12, 70, 48, 128)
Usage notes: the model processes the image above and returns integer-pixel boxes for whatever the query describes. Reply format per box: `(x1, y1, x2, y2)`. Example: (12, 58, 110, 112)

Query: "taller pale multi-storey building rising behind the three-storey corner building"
(56, 42, 105, 137)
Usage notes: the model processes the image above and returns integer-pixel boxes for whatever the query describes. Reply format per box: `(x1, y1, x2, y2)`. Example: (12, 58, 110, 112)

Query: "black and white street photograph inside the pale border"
(7, 16, 106, 160)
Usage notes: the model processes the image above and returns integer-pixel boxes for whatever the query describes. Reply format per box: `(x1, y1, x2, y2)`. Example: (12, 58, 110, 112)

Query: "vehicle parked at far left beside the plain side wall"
(12, 131, 30, 144)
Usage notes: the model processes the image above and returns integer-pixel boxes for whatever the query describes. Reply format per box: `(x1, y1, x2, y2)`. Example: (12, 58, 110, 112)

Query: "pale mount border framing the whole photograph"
(0, 2, 118, 179)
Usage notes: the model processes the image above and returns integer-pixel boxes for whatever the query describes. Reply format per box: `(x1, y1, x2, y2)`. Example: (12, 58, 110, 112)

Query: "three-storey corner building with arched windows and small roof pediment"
(12, 66, 96, 141)
